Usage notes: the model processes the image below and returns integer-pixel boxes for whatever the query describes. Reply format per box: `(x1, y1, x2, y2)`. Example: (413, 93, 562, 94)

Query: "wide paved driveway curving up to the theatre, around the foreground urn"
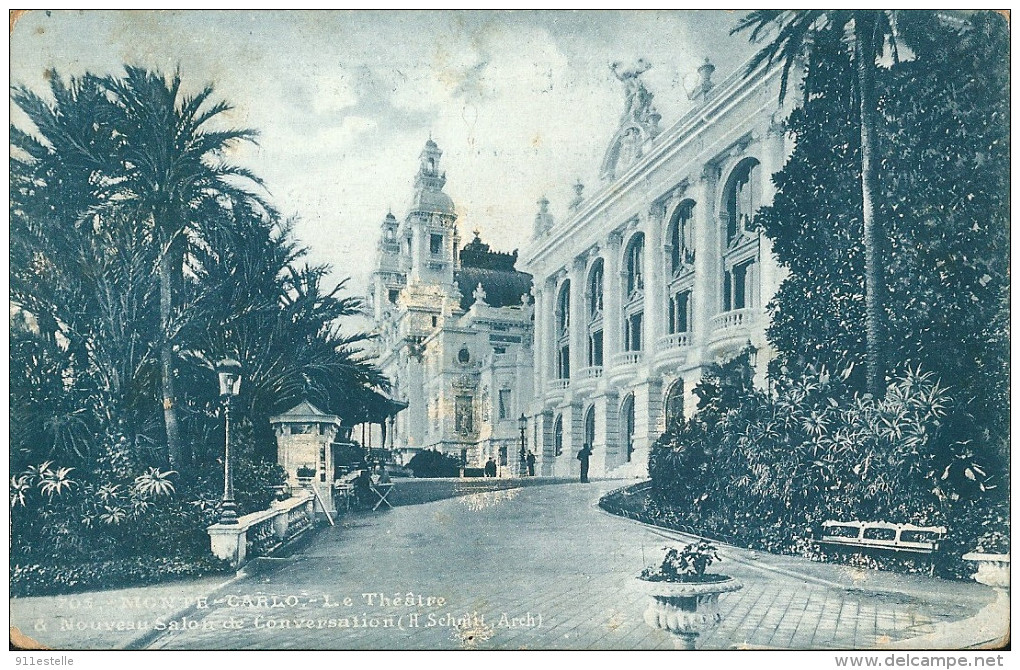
(11, 481, 1008, 650)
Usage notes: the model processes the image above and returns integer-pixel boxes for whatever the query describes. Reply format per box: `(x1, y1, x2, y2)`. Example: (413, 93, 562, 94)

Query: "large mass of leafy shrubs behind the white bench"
(646, 353, 1009, 574)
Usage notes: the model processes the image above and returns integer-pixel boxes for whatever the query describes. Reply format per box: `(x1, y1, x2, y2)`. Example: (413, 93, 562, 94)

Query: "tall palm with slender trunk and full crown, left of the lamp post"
(104, 66, 261, 469)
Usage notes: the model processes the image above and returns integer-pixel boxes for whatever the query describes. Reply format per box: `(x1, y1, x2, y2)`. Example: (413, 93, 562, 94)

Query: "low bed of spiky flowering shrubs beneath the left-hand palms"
(10, 436, 285, 596)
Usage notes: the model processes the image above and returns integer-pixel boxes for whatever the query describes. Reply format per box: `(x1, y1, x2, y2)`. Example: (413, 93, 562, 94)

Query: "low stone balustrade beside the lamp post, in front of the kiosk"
(206, 491, 314, 567)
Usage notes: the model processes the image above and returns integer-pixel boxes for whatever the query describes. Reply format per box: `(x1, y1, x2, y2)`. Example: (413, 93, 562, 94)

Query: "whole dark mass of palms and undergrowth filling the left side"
(10, 67, 381, 580)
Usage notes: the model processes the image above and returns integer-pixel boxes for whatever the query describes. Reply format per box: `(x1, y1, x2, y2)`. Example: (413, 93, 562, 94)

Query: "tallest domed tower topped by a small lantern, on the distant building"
(405, 139, 460, 287)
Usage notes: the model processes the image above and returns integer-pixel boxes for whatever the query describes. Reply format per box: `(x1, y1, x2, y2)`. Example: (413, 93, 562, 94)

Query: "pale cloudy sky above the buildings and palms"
(10, 10, 754, 303)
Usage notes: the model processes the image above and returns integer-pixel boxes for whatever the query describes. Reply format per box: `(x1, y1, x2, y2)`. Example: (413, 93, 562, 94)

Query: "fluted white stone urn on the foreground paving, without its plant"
(638, 577, 744, 650)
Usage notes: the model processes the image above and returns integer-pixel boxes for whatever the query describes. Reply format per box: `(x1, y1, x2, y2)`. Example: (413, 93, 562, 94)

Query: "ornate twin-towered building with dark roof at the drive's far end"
(369, 140, 533, 474)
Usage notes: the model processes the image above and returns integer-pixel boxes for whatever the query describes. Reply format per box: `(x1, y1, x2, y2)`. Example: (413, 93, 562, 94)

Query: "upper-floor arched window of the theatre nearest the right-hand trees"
(722, 158, 761, 311)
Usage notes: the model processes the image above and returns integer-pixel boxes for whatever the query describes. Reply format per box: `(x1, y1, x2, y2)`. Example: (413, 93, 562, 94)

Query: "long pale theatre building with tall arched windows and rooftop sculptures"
(519, 60, 796, 476)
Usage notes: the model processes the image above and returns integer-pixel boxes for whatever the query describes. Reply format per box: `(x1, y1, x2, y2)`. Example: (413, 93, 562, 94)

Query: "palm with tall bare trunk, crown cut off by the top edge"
(730, 9, 901, 397)
